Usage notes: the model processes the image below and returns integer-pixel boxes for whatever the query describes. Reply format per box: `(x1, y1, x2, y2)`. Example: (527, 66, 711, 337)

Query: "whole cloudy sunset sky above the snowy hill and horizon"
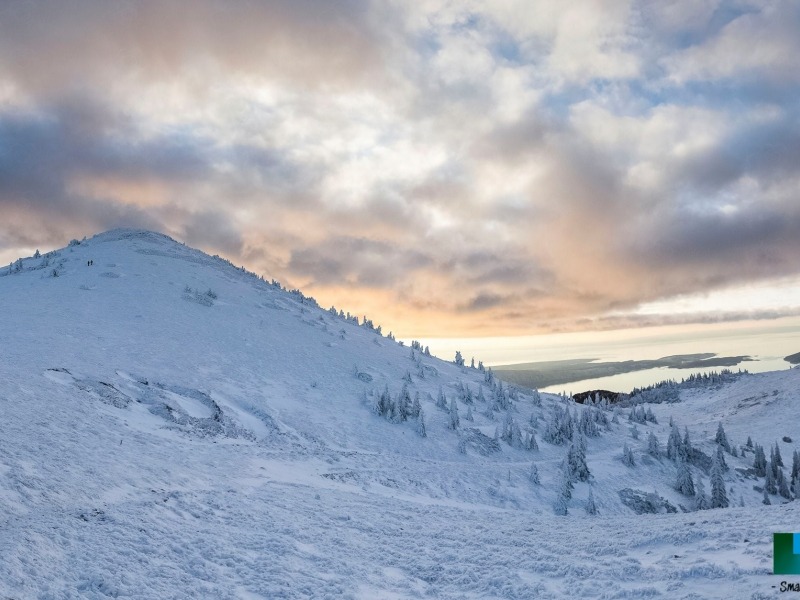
(0, 0, 800, 337)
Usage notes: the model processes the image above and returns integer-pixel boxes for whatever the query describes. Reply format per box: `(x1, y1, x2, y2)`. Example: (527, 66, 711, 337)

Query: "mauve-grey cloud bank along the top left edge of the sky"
(0, 0, 382, 94)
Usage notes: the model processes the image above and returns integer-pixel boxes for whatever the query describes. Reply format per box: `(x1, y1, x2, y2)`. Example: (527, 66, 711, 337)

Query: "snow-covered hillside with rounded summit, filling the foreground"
(0, 230, 800, 598)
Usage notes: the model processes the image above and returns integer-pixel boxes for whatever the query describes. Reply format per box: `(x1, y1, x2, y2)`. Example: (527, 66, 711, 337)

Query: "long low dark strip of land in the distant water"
(492, 352, 752, 389)
